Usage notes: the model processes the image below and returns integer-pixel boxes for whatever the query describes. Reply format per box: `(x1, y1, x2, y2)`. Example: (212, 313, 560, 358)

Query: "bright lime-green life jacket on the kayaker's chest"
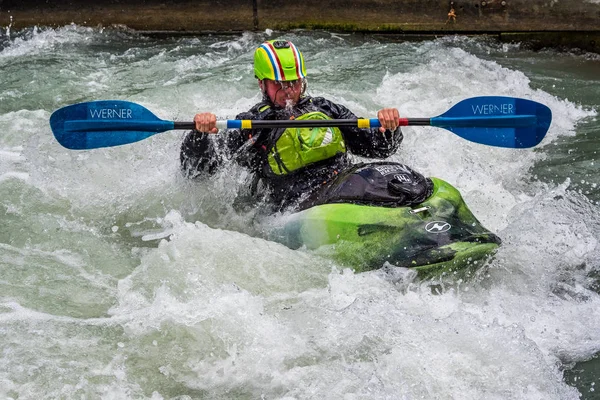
(267, 111, 346, 175)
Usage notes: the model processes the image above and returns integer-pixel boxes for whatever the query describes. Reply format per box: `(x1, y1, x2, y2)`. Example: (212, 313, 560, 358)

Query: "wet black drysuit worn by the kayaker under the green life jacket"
(181, 96, 403, 210)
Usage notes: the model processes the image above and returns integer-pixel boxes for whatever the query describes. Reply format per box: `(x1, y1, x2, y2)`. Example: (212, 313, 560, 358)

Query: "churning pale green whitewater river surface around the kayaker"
(0, 26, 600, 400)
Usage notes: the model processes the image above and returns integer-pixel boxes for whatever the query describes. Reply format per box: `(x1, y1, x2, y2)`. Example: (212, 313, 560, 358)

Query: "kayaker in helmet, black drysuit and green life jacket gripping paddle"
(181, 40, 403, 210)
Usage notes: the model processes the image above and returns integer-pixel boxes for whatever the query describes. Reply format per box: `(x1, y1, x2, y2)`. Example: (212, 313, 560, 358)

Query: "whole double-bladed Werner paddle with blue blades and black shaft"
(50, 96, 552, 150)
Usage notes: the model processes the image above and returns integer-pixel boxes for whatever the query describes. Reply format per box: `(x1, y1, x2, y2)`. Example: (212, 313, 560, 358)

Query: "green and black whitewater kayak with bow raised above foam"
(271, 163, 501, 279)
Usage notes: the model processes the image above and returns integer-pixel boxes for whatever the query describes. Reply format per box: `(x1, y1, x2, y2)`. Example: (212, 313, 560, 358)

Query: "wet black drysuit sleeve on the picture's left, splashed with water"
(179, 112, 253, 178)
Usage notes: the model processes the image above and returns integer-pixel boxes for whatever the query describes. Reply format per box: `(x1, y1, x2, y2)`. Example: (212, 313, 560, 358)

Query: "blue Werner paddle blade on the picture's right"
(431, 96, 552, 148)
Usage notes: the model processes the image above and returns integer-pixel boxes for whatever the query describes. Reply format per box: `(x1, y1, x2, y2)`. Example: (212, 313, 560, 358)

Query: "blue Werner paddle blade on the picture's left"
(50, 100, 174, 150)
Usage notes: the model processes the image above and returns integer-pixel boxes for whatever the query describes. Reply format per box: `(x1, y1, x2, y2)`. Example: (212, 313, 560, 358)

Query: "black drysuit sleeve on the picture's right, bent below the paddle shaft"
(314, 98, 404, 158)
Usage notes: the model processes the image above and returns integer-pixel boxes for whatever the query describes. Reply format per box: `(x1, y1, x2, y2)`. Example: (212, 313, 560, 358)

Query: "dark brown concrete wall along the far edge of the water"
(0, 0, 600, 52)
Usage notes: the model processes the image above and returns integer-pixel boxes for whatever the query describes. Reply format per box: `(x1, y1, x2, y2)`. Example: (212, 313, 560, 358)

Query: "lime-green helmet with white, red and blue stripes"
(254, 40, 306, 81)
